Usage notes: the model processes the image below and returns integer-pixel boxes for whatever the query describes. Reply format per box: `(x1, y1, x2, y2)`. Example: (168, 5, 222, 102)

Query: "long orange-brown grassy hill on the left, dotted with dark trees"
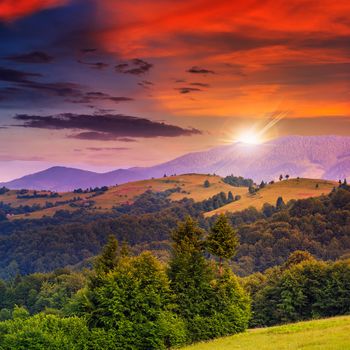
(0, 174, 239, 219)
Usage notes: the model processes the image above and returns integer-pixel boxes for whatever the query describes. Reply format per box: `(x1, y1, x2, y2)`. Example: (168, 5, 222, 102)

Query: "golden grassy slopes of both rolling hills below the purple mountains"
(0, 174, 337, 218)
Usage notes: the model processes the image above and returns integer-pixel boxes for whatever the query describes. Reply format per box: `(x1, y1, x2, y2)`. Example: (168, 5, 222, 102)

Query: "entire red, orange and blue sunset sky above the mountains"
(0, 0, 350, 181)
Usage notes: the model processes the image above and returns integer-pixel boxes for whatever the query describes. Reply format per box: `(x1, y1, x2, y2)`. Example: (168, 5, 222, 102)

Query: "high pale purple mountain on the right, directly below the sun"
(151, 136, 350, 182)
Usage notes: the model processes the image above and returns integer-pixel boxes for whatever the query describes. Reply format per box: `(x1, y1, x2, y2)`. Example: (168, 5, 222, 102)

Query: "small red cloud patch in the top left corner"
(0, 0, 69, 21)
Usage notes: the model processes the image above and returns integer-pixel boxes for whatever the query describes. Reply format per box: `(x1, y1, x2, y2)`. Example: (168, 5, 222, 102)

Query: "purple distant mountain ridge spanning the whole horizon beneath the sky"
(0, 136, 350, 191)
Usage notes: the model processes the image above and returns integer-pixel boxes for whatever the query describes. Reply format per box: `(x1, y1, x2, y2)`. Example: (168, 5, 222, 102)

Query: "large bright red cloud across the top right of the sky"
(97, 0, 350, 57)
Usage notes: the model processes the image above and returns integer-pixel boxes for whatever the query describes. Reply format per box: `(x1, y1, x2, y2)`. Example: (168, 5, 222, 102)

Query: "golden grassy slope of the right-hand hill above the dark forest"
(207, 179, 337, 216)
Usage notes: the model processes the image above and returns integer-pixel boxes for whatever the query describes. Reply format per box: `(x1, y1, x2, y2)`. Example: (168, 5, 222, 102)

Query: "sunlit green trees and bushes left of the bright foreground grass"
(0, 216, 250, 350)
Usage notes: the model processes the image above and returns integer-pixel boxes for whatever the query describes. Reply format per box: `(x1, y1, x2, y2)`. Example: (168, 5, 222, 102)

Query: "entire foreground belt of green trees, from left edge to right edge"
(0, 215, 350, 350)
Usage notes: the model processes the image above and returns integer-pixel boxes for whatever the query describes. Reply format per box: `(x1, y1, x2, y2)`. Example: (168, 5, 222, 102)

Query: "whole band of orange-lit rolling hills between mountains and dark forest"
(0, 174, 338, 219)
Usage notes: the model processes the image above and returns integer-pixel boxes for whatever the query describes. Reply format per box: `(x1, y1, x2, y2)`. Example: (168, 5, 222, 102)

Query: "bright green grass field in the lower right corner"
(182, 316, 350, 350)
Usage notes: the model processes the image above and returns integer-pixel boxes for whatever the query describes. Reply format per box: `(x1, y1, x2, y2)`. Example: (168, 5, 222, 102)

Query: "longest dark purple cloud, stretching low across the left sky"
(14, 113, 201, 140)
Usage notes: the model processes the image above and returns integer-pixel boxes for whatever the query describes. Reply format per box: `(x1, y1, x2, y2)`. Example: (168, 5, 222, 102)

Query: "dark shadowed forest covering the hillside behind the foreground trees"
(0, 184, 350, 279)
